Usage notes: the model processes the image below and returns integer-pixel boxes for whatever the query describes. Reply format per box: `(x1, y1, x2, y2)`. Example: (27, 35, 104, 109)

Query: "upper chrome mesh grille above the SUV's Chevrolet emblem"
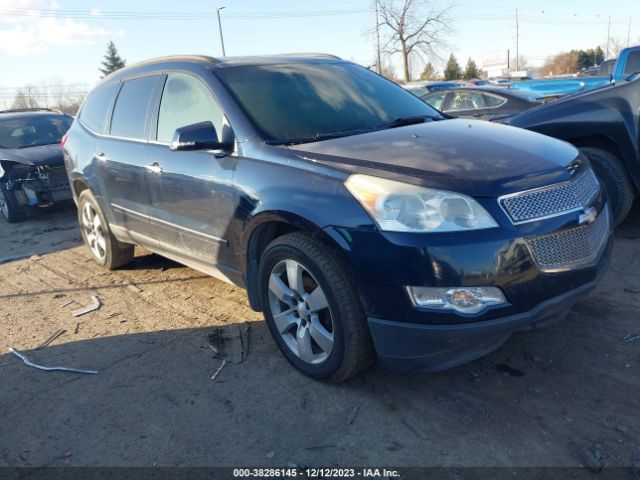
(499, 168, 600, 224)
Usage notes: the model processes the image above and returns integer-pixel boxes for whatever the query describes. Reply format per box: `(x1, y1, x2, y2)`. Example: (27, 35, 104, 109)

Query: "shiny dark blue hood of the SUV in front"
(290, 120, 578, 197)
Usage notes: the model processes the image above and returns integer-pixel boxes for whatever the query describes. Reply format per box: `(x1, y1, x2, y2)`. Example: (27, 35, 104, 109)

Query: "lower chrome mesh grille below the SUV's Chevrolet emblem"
(526, 208, 611, 271)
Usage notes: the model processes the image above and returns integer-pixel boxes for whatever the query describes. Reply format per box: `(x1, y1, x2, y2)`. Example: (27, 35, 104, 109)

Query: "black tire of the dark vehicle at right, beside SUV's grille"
(580, 147, 635, 227)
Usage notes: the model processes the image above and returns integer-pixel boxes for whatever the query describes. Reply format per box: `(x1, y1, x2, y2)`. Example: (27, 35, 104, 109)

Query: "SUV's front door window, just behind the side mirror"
(157, 75, 224, 142)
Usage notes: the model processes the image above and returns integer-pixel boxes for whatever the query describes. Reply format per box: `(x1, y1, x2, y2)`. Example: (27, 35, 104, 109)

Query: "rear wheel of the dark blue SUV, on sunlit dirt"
(78, 190, 134, 270)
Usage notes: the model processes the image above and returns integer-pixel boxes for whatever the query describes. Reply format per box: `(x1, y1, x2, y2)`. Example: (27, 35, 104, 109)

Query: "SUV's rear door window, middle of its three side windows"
(110, 76, 158, 139)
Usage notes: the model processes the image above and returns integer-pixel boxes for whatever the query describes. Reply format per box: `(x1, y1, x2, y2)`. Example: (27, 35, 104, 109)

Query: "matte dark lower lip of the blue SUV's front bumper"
(368, 242, 612, 372)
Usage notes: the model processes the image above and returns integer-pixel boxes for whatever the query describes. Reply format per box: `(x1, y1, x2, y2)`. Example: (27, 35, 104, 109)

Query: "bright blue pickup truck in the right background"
(511, 45, 640, 97)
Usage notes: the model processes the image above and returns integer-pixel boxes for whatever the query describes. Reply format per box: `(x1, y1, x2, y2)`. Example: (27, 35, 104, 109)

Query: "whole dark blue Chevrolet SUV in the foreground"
(64, 55, 612, 381)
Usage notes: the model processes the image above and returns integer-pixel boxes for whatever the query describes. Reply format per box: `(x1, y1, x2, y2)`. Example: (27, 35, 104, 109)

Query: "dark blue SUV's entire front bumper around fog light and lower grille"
(325, 198, 613, 371)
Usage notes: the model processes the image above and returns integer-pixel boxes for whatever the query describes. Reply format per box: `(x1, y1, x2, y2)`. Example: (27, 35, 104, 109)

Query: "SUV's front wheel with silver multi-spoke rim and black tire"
(258, 233, 373, 382)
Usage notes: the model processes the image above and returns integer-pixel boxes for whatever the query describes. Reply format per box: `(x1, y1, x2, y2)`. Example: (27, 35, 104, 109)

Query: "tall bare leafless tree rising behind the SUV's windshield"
(375, 0, 453, 82)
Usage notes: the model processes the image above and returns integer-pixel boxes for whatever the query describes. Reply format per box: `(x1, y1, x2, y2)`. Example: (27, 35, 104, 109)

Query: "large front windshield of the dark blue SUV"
(216, 62, 441, 144)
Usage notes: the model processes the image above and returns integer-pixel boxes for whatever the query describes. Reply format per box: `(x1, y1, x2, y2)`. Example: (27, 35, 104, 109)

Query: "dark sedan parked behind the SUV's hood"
(421, 87, 542, 121)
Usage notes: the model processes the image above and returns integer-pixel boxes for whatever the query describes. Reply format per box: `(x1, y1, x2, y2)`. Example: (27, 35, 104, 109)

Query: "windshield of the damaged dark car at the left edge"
(0, 115, 72, 149)
